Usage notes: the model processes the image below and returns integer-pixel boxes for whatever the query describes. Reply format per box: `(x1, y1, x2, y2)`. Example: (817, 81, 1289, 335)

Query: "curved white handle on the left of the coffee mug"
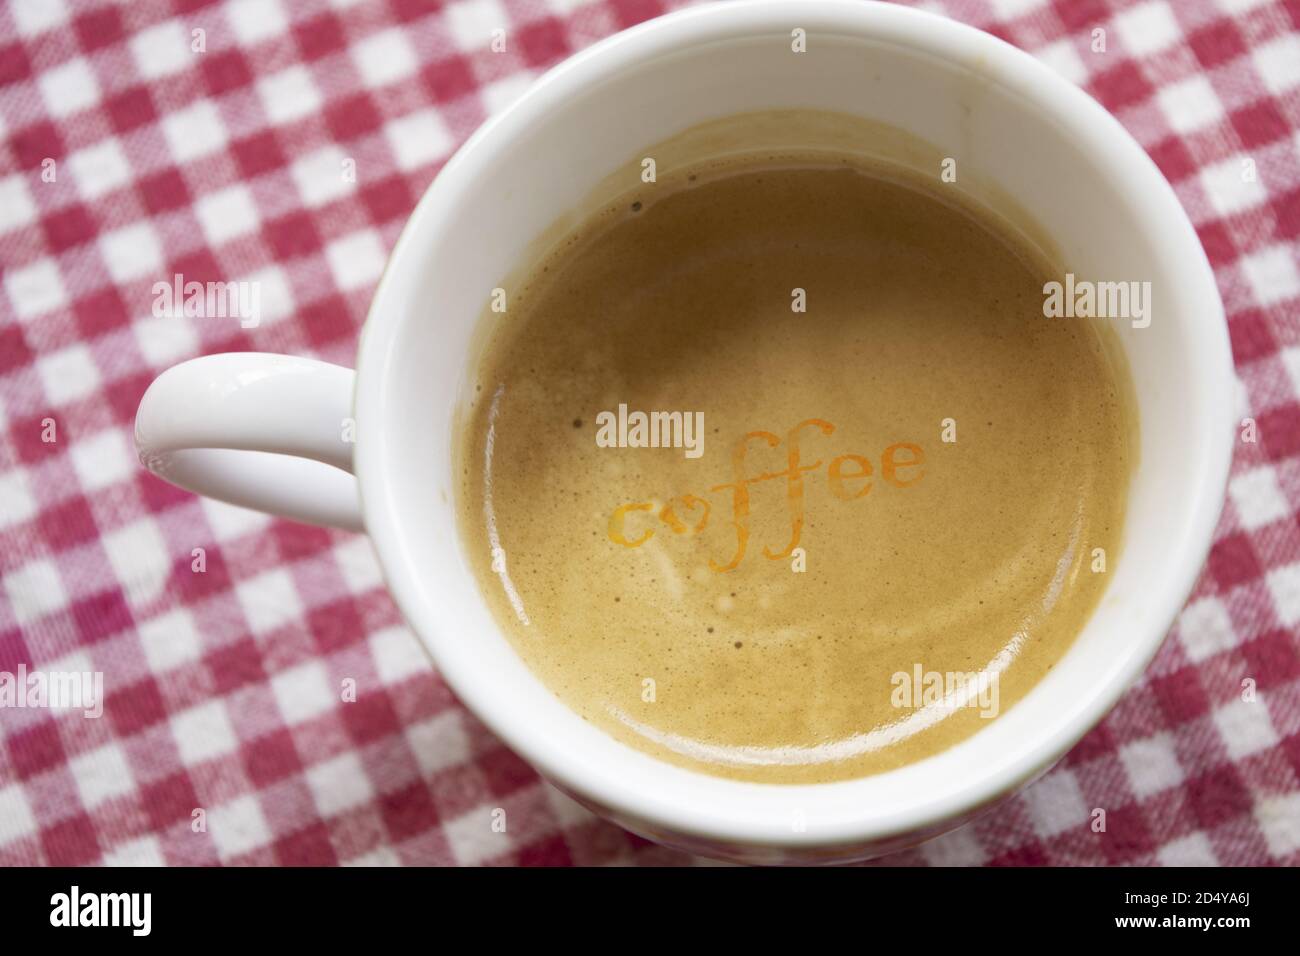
(135, 352, 365, 531)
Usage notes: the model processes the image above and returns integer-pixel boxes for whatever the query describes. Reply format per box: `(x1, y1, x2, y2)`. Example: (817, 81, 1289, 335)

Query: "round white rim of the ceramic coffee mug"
(354, 0, 1235, 848)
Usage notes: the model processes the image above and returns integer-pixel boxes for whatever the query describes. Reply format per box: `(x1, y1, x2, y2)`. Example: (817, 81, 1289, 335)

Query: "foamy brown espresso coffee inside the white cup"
(456, 143, 1136, 783)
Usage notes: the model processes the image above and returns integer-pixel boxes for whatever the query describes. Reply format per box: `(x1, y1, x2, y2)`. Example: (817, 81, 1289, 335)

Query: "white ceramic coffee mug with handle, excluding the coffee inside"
(135, 0, 1234, 862)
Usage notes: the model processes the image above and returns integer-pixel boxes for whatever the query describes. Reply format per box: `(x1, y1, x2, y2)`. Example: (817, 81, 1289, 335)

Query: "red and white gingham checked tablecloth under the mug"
(0, 0, 1300, 865)
